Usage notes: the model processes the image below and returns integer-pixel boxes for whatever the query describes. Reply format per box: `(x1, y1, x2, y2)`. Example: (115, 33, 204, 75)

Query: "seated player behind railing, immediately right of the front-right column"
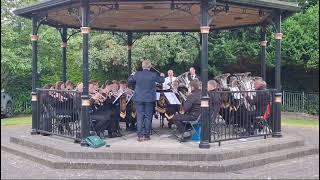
(208, 80, 222, 120)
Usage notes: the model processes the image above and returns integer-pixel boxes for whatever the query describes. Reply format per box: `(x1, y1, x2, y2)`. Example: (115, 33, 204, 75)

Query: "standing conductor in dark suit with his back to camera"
(128, 60, 164, 142)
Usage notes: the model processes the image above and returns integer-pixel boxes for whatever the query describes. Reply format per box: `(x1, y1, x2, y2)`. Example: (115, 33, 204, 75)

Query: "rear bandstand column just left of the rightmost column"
(260, 26, 268, 81)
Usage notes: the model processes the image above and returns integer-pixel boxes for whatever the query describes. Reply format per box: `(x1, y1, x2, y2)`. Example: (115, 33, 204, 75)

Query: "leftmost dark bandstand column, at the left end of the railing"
(31, 16, 38, 135)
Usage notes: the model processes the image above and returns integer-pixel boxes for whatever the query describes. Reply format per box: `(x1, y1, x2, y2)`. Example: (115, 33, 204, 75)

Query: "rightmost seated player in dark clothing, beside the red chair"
(242, 79, 271, 135)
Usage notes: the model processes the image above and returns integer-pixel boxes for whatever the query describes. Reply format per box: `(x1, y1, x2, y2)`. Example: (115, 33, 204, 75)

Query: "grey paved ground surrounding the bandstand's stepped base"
(1, 125, 319, 179)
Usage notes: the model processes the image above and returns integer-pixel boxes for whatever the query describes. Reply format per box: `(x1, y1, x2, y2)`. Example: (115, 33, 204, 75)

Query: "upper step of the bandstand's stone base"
(10, 137, 304, 162)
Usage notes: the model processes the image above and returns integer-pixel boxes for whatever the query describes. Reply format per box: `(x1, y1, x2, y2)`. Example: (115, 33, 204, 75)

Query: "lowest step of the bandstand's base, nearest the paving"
(1, 143, 319, 172)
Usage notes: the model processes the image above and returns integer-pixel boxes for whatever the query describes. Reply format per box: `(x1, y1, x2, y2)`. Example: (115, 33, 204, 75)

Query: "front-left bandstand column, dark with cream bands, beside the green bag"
(81, 1, 90, 146)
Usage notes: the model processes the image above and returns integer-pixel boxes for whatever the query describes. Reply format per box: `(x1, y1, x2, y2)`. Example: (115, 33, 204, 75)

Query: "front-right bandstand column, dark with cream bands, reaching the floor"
(199, 0, 210, 149)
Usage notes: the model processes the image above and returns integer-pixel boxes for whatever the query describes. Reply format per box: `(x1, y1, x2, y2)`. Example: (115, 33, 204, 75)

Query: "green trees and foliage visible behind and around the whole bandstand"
(1, 0, 319, 112)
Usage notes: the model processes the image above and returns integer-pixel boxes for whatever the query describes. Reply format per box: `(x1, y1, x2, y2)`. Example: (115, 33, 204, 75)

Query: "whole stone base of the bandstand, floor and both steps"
(1, 122, 319, 172)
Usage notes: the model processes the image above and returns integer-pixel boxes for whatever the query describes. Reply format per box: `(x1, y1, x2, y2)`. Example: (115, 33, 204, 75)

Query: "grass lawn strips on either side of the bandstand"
(1, 116, 319, 128)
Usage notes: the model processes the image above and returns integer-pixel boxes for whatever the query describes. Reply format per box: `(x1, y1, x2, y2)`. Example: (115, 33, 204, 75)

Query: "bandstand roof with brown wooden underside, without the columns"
(14, 0, 300, 32)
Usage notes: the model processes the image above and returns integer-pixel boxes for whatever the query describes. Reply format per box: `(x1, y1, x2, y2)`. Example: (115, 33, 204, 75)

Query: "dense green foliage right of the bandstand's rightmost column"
(282, 3, 319, 69)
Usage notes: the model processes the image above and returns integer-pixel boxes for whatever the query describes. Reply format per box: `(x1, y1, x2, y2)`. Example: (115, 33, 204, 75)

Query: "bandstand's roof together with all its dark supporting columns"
(14, 0, 300, 148)
